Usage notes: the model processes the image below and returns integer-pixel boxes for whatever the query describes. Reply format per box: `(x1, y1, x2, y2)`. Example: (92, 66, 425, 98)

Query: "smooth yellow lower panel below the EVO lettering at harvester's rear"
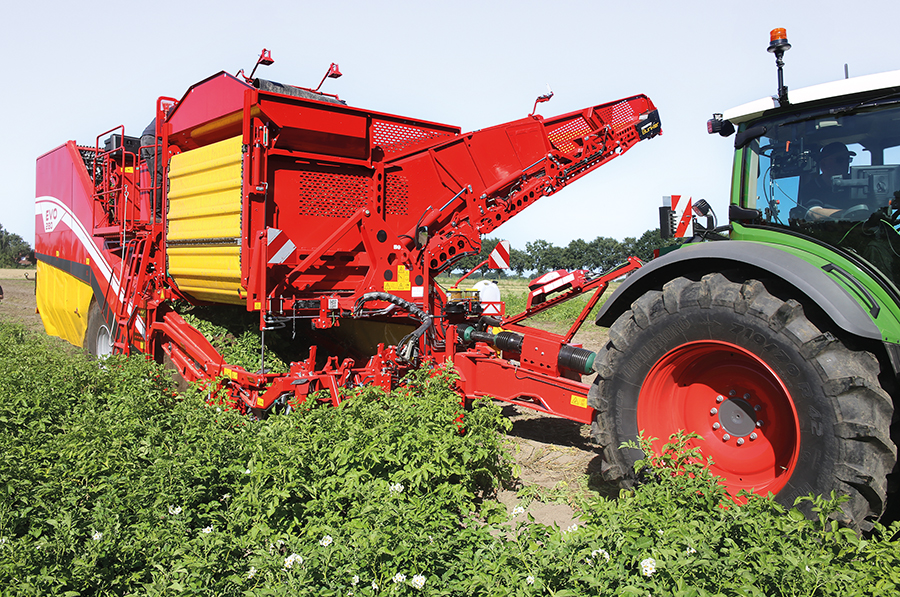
(37, 261, 94, 346)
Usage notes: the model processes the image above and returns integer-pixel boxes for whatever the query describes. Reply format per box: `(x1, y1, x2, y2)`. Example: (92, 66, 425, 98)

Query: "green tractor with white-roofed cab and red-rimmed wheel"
(589, 29, 900, 530)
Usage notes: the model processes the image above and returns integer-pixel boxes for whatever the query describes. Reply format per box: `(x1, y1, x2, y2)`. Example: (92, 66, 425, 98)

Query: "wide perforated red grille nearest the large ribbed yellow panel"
(298, 172, 369, 218)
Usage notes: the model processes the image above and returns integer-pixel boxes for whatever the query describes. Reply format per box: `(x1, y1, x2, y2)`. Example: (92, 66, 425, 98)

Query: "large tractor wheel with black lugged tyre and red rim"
(588, 273, 897, 530)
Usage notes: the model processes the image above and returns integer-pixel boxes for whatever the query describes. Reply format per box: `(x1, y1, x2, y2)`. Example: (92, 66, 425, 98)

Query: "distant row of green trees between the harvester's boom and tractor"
(453, 228, 677, 277)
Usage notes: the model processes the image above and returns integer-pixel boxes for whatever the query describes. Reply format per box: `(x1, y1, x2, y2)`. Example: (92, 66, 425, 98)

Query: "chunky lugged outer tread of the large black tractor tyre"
(588, 273, 897, 528)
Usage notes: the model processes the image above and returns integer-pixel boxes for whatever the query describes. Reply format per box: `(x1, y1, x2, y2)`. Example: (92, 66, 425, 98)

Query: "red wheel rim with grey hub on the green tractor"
(637, 340, 800, 497)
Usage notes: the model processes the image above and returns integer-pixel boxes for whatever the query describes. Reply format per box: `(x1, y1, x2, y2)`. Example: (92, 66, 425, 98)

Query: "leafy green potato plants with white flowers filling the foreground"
(0, 322, 900, 597)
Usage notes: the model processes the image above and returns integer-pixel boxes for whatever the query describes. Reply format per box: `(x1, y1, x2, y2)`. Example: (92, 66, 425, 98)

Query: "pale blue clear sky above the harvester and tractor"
(0, 0, 900, 249)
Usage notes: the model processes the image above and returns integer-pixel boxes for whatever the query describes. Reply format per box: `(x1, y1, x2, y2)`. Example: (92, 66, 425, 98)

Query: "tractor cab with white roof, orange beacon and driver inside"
(708, 41, 900, 286)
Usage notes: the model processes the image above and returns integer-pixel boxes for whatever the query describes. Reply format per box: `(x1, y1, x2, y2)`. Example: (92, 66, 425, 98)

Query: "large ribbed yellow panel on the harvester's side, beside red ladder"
(167, 137, 244, 304)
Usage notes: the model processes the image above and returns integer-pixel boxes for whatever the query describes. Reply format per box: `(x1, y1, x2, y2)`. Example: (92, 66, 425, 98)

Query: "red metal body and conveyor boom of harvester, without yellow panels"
(36, 65, 660, 423)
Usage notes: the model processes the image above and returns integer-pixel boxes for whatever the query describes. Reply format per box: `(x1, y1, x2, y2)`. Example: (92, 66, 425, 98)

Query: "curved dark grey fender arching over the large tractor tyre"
(597, 240, 881, 340)
